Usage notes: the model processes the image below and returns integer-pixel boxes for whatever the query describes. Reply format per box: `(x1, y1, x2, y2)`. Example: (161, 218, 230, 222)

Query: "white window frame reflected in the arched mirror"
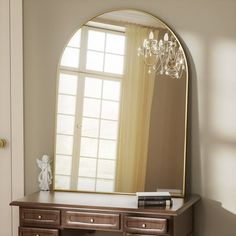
(57, 26, 125, 191)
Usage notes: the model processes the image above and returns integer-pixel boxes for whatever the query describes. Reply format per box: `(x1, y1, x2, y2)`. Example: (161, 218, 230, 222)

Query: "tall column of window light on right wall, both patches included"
(205, 39, 236, 214)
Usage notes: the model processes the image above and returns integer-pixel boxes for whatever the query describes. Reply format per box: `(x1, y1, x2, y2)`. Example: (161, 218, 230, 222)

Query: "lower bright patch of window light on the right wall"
(207, 147, 236, 214)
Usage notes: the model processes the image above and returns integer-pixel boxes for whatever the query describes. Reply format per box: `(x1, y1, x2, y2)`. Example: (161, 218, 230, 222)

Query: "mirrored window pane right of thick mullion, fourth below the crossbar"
(80, 138, 98, 157)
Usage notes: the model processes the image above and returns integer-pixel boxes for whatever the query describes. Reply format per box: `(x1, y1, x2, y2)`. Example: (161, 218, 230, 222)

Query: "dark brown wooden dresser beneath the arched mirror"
(11, 191, 200, 236)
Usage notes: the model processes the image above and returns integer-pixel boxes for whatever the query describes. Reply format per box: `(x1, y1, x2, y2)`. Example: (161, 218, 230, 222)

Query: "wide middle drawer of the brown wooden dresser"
(62, 211, 120, 230)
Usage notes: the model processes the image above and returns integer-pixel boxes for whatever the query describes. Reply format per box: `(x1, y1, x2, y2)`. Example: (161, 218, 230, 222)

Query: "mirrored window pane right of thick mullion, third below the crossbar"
(82, 118, 99, 138)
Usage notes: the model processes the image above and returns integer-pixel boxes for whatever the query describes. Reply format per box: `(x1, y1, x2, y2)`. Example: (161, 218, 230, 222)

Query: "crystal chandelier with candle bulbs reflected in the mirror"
(138, 31, 185, 79)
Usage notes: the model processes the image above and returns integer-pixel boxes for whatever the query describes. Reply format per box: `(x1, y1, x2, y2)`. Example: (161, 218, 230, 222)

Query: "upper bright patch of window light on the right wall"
(209, 39, 236, 138)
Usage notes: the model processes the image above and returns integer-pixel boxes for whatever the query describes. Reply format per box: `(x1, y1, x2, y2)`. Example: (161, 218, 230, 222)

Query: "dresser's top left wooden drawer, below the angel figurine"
(20, 208, 60, 226)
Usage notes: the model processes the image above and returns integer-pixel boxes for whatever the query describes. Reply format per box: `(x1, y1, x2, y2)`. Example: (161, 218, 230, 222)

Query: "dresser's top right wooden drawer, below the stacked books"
(124, 216, 167, 234)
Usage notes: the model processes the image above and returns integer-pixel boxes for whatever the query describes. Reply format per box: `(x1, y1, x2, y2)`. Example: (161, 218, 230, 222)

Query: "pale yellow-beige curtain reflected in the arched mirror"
(116, 25, 158, 192)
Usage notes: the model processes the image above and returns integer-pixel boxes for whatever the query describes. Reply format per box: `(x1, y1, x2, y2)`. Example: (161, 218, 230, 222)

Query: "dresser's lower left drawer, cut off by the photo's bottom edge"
(19, 227, 59, 236)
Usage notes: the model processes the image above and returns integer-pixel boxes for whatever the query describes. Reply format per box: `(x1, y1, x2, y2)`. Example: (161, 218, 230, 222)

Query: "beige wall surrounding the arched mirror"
(24, 0, 236, 236)
